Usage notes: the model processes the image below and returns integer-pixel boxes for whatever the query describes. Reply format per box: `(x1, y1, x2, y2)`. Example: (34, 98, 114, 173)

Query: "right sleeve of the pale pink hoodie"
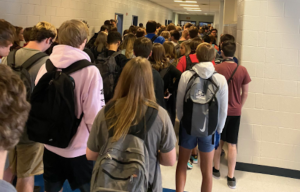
(82, 67, 105, 130)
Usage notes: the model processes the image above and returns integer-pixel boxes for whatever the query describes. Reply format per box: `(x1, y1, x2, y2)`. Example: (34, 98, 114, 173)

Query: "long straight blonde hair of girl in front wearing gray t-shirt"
(105, 57, 158, 141)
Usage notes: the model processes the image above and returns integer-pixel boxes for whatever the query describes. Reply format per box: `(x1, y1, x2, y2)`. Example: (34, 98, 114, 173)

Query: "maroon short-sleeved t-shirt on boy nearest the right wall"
(215, 62, 251, 116)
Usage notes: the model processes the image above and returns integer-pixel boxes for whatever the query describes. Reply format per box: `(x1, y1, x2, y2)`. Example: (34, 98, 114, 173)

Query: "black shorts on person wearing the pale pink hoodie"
(44, 148, 94, 192)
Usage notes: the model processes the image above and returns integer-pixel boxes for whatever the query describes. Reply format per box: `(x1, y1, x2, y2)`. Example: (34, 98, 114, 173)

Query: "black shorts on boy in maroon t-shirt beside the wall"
(221, 116, 241, 144)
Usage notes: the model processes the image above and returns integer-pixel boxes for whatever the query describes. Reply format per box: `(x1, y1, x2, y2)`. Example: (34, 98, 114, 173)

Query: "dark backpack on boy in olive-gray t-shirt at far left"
(7, 50, 48, 101)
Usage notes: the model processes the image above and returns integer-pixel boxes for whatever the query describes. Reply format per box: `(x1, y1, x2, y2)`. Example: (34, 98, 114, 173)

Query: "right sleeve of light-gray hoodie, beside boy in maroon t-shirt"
(217, 75, 228, 133)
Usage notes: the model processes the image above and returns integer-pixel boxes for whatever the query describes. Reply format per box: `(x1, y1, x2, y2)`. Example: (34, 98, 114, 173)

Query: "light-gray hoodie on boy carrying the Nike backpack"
(176, 62, 228, 133)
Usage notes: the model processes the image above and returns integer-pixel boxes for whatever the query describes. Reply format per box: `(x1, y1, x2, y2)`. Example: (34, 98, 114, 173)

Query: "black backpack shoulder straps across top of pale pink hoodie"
(46, 59, 93, 75)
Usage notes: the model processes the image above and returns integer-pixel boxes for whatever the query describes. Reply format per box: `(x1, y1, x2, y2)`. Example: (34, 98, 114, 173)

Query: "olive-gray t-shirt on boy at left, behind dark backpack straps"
(1, 47, 49, 144)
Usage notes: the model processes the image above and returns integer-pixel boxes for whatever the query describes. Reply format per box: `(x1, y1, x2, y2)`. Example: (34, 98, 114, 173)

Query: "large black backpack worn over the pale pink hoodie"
(27, 59, 93, 148)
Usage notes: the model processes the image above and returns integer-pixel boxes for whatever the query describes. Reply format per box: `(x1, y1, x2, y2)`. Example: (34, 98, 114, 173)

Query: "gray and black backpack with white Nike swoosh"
(182, 70, 219, 140)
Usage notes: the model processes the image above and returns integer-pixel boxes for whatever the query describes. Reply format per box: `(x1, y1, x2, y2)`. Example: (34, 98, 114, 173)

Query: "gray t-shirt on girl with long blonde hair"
(87, 107, 176, 192)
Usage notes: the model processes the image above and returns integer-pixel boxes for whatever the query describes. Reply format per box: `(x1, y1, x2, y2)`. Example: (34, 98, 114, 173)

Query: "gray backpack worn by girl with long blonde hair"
(91, 104, 158, 192)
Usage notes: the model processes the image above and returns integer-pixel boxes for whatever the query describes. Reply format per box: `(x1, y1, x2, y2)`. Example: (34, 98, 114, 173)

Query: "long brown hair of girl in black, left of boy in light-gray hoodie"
(149, 43, 170, 72)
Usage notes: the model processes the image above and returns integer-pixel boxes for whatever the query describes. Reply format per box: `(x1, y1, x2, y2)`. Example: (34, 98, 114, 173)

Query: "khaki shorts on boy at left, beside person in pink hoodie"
(9, 143, 44, 178)
